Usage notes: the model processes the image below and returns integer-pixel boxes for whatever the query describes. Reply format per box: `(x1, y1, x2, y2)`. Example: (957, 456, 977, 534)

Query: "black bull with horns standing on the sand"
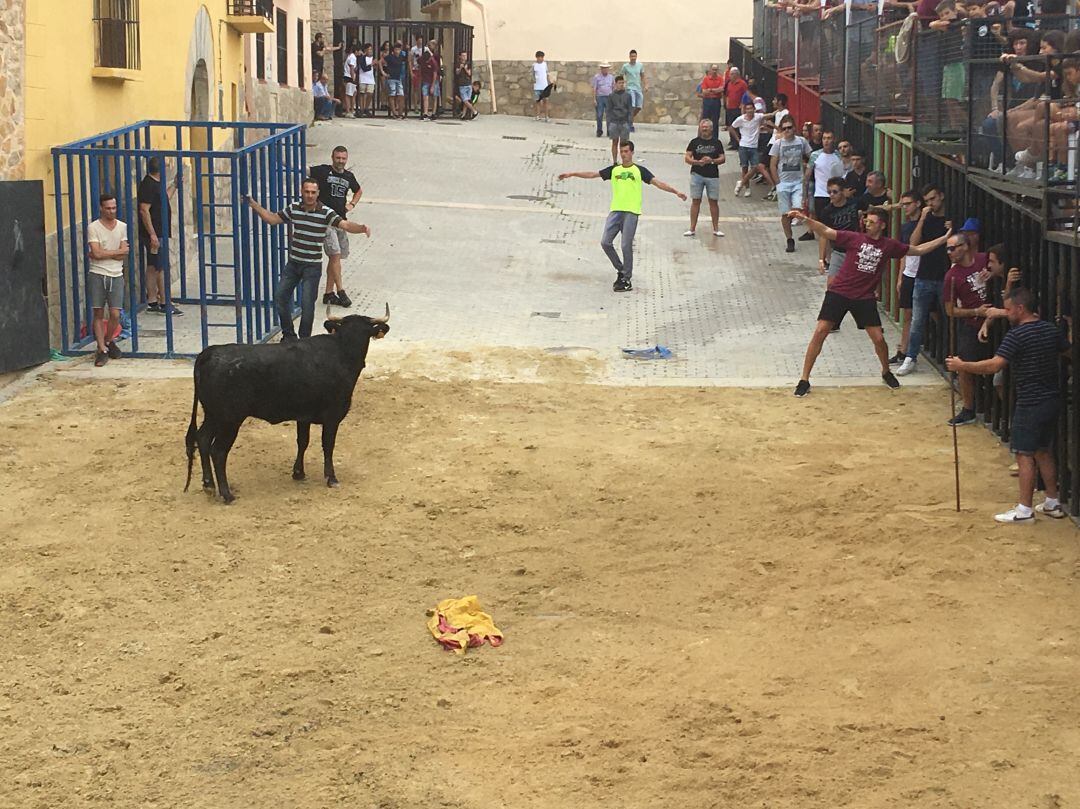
(184, 306, 390, 503)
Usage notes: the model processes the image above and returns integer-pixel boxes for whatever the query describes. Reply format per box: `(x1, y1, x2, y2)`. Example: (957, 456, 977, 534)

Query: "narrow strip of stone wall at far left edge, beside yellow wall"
(0, 0, 26, 179)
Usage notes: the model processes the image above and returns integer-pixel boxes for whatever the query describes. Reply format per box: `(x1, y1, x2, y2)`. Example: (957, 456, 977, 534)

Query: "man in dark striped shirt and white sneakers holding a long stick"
(945, 287, 1069, 525)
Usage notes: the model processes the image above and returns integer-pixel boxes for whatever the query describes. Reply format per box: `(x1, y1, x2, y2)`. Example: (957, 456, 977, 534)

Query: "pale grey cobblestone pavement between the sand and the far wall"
(145, 116, 940, 387)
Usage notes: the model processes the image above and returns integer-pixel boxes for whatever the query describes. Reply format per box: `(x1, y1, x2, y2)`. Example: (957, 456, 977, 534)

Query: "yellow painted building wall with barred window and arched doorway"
(26, 0, 243, 222)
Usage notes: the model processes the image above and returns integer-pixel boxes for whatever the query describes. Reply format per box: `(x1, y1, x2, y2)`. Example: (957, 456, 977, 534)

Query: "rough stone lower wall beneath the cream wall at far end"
(492, 60, 708, 123)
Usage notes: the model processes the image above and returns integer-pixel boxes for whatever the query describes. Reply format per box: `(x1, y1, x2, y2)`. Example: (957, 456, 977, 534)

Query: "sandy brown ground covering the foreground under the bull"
(0, 360, 1080, 809)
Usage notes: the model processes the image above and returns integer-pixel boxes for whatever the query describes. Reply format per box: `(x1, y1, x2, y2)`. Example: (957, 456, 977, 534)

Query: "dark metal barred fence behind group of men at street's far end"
(334, 19, 473, 114)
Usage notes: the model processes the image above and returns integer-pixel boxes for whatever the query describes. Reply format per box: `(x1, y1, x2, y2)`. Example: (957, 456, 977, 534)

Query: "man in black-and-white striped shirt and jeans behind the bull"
(245, 177, 372, 342)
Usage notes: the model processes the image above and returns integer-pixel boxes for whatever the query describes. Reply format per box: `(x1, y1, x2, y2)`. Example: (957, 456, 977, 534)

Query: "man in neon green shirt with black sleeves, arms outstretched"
(558, 140, 686, 292)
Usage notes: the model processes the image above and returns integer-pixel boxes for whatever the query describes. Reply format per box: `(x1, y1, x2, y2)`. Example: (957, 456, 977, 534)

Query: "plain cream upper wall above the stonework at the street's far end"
(460, 0, 754, 65)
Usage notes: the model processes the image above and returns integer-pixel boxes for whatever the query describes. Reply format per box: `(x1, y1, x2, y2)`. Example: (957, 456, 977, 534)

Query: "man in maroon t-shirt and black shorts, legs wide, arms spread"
(788, 207, 953, 396)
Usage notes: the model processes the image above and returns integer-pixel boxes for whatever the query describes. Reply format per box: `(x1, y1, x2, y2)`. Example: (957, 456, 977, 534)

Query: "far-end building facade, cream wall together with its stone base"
(422, 0, 753, 123)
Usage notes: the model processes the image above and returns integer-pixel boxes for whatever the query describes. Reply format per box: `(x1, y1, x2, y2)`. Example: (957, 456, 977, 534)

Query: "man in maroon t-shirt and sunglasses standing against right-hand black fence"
(943, 233, 994, 427)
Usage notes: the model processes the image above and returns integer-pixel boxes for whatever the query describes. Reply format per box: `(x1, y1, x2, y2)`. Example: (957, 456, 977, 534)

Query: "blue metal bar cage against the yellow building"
(52, 121, 307, 356)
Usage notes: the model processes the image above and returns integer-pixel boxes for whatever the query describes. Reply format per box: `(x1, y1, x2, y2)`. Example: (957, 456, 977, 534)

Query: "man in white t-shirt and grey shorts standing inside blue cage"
(86, 193, 129, 367)
